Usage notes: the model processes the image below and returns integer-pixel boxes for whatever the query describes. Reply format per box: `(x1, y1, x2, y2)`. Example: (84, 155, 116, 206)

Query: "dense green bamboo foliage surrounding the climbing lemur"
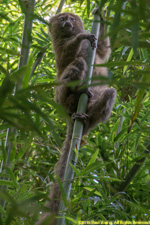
(0, 0, 150, 225)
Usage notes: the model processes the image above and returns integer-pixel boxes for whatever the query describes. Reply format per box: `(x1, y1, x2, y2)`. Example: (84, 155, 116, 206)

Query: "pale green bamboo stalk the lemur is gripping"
(57, 11, 100, 225)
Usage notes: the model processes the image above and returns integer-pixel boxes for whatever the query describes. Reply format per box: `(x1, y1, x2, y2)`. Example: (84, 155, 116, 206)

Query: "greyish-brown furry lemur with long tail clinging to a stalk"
(36, 10, 116, 225)
